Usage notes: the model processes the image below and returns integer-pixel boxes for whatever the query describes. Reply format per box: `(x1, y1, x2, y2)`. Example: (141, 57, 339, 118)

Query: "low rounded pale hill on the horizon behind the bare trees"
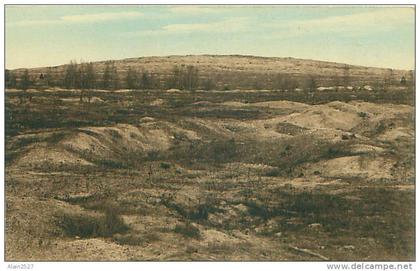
(6, 55, 412, 89)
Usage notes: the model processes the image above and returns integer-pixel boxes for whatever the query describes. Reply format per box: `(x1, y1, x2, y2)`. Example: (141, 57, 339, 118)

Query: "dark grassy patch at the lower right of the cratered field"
(244, 188, 414, 257)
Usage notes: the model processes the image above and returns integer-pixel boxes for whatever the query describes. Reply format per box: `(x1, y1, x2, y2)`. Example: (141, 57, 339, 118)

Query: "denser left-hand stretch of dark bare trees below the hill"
(5, 61, 202, 92)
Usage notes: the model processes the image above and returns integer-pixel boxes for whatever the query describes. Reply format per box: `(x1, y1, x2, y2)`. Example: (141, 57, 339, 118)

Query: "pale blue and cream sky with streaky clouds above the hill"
(6, 5, 415, 69)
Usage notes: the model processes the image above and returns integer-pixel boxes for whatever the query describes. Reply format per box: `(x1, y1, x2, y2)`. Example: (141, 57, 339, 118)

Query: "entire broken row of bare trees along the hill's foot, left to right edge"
(5, 61, 413, 95)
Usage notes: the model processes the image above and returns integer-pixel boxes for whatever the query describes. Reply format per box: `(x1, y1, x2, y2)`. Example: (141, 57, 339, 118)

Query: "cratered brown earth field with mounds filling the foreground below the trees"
(6, 89, 415, 261)
